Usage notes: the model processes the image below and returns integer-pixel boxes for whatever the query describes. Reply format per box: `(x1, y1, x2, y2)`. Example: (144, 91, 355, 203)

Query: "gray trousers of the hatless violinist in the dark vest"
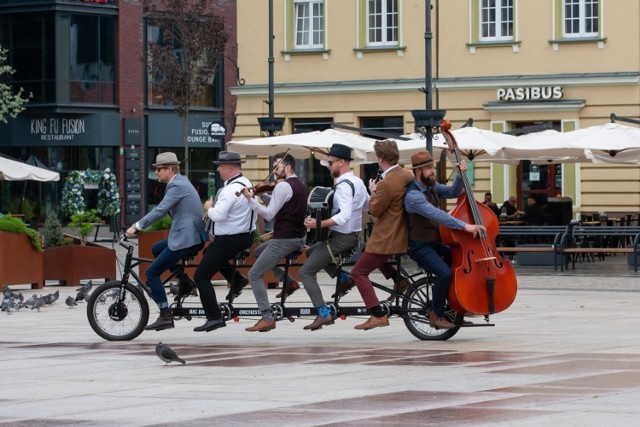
(248, 237, 303, 320)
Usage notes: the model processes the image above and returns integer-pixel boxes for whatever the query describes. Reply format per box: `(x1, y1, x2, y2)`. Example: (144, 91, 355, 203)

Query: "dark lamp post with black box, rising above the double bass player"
(411, 0, 447, 154)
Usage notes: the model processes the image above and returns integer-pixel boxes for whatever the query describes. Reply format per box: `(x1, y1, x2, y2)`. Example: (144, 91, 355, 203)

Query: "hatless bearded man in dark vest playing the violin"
(242, 153, 309, 332)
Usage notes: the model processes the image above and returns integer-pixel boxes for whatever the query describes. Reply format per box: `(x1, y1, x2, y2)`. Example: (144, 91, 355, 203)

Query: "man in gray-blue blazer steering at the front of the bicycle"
(126, 153, 207, 331)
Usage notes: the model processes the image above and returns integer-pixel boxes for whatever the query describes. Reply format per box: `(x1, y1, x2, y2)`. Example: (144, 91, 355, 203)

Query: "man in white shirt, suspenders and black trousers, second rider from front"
(193, 151, 256, 332)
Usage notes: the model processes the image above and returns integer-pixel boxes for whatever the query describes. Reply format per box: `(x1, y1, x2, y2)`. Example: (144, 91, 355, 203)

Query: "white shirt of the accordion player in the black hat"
(329, 172, 369, 234)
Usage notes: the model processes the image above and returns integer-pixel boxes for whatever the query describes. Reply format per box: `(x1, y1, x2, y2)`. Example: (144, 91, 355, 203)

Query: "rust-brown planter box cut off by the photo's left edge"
(0, 231, 44, 289)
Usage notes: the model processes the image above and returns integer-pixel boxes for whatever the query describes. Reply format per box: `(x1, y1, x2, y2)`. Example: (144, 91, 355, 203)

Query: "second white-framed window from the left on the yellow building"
(367, 0, 398, 46)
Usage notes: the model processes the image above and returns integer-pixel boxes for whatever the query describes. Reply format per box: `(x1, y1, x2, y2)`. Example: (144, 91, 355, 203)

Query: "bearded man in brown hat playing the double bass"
(404, 151, 485, 329)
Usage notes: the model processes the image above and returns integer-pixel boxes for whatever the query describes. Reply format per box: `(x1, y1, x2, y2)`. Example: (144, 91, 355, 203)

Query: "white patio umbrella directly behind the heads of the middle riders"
(227, 129, 376, 163)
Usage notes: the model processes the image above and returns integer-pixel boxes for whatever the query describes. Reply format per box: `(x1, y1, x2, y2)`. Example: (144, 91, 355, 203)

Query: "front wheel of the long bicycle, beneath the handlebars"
(87, 280, 149, 341)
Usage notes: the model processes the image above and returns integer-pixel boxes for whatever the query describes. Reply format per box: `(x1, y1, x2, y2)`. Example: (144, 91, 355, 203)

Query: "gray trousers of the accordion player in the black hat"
(300, 231, 358, 308)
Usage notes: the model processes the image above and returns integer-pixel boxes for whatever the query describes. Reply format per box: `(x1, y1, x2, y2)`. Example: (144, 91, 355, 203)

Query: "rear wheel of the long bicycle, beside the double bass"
(402, 277, 460, 341)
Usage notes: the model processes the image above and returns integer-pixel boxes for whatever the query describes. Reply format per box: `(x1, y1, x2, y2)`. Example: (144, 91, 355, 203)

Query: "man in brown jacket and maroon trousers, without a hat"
(351, 140, 413, 330)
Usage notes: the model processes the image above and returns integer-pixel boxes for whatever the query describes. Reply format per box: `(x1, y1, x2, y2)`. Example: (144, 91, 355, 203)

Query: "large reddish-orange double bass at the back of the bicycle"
(440, 120, 517, 316)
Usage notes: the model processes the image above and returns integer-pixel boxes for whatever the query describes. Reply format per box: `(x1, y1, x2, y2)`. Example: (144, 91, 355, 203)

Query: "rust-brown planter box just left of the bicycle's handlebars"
(42, 245, 116, 286)
